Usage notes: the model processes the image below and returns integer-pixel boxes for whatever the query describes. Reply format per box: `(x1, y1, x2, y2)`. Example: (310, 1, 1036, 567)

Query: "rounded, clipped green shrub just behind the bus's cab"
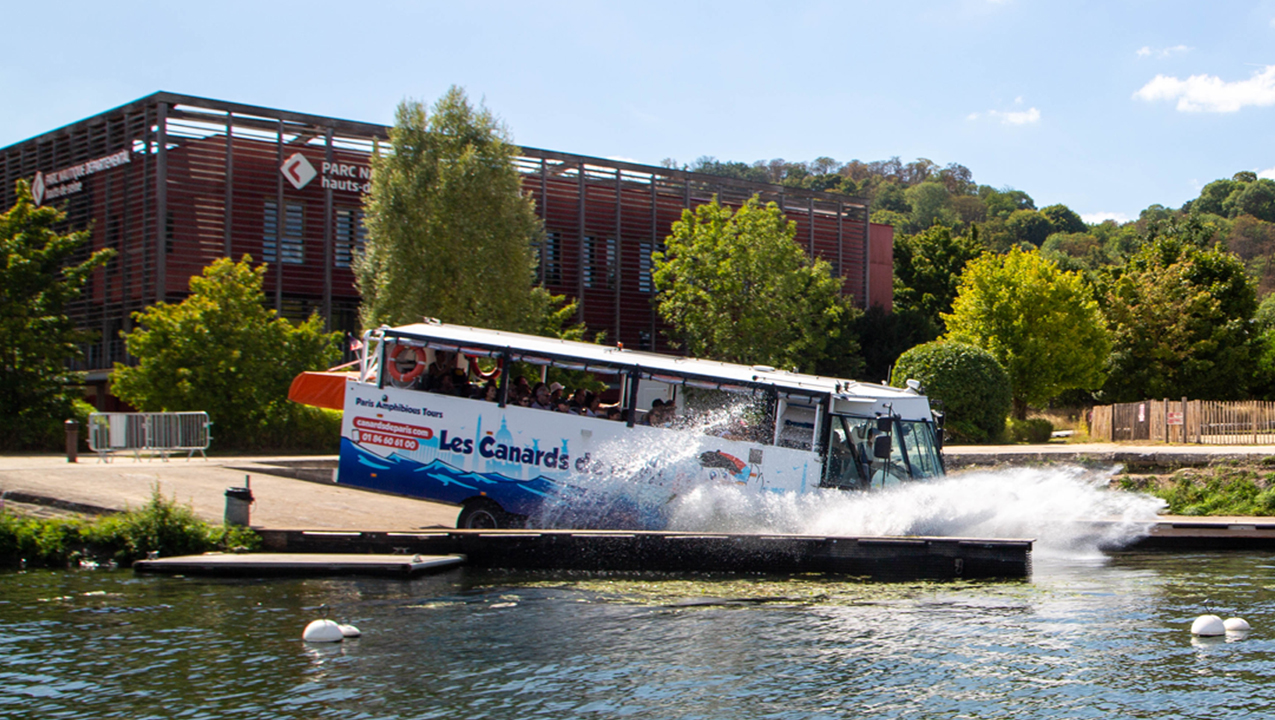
(891, 342, 1010, 442)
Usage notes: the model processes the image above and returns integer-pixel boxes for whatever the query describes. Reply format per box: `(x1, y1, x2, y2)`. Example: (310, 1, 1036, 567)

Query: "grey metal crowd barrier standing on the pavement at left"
(88, 413, 213, 461)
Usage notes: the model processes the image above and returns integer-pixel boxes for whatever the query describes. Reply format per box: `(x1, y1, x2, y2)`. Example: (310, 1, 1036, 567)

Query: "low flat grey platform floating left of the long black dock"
(133, 553, 465, 577)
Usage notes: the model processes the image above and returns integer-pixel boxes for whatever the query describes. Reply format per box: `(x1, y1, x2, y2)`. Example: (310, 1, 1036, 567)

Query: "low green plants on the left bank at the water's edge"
(0, 486, 261, 567)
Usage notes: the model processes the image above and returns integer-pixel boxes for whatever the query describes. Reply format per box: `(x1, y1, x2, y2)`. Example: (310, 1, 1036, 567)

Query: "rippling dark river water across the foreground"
(7, 468, 1275, 720)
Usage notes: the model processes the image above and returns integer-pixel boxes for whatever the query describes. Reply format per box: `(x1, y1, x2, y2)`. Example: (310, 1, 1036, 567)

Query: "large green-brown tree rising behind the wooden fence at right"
(1102, 234, 1257, 403)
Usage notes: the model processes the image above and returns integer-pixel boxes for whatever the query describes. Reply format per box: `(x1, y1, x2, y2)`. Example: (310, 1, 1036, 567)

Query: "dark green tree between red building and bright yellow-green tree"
(894, 226, 983, 328)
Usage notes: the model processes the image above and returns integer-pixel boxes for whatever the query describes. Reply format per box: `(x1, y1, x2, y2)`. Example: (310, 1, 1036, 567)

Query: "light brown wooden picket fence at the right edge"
(1089, 398, 1275, 445)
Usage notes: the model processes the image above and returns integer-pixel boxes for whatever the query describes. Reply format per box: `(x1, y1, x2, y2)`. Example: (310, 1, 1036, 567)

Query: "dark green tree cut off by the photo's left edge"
(0, 180, 115, 450)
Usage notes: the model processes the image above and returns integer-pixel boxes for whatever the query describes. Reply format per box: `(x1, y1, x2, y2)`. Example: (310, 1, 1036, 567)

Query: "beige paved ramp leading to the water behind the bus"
(0, 455, 459, 531)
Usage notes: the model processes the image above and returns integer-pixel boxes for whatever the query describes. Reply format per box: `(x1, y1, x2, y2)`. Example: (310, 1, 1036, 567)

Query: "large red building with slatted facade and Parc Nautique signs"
(0, 93, 893, 401)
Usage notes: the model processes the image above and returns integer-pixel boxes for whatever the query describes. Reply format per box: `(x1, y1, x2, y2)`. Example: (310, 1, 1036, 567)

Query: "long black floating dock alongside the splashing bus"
(221, 529, 1031, 580)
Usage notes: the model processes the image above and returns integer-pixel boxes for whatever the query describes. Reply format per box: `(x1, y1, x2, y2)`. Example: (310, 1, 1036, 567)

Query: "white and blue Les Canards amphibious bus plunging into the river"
(291, 321, 944, 529)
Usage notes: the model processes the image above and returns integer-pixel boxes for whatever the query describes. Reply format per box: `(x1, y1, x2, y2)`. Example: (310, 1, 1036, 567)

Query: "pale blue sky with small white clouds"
(0, 0, 1275, 220)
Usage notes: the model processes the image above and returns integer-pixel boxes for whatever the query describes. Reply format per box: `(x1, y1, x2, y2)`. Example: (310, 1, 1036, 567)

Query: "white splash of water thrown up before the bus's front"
(669, 465, 1164, 557)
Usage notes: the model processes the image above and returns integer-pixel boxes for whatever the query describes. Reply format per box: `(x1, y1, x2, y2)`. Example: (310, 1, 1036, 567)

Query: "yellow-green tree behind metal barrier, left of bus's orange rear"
(112, 256, 338, 449)
